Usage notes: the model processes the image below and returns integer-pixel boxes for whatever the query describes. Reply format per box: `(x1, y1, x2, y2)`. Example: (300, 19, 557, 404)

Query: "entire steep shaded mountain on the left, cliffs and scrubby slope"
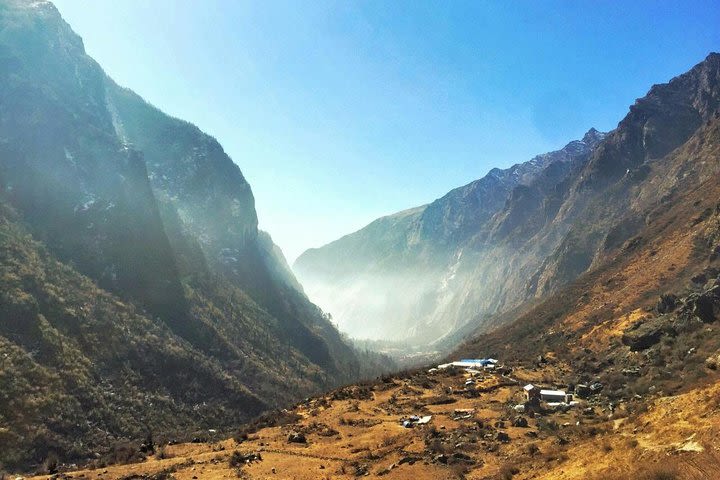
(0, 0, 385, 466)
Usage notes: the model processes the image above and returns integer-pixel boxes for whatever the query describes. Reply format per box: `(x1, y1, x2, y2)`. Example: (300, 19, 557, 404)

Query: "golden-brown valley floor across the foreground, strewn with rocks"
(22, 361, 720, 480)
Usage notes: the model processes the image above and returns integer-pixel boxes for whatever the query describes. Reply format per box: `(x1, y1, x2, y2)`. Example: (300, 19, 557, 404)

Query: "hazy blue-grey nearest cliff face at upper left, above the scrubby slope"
(0, 2, 188, 326)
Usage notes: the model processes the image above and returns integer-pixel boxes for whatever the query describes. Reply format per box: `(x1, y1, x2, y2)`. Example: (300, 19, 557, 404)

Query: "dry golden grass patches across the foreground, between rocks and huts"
(19, 366, 720, 480)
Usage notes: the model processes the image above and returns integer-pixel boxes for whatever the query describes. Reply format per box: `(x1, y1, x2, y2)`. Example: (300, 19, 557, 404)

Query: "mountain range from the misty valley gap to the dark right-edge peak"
(294, 53, 720, 346)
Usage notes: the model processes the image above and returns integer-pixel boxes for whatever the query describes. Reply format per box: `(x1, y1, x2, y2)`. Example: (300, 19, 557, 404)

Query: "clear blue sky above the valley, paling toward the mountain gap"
(55, 0, 720, 261)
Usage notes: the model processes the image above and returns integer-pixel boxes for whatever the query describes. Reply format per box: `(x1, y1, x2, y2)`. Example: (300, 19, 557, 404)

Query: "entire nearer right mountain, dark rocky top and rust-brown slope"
(461, 53, 720, 362)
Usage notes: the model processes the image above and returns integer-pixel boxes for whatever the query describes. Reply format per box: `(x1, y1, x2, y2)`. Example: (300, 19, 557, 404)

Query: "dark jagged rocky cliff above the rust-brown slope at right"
(534, 53, 720, 296)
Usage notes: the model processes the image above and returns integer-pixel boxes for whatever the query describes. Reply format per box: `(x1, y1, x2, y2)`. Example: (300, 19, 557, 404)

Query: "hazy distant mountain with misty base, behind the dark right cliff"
(294, 125, 605, 342)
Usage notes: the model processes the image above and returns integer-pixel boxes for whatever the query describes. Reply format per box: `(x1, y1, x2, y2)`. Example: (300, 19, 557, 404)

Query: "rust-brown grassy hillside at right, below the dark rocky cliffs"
(457, 114, 720, 389)
